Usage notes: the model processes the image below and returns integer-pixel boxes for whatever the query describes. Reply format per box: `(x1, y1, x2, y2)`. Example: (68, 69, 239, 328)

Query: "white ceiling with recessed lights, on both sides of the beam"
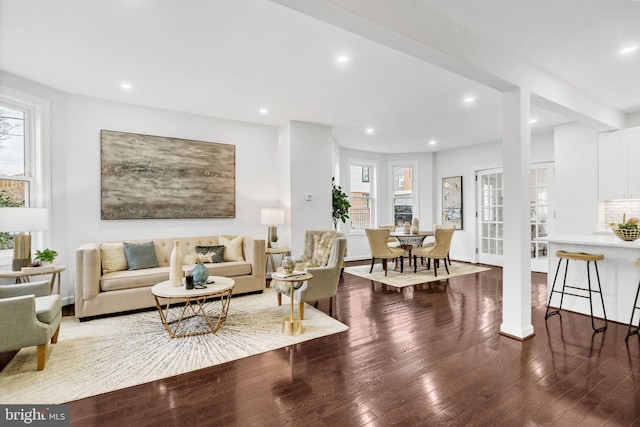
(0, 0, 640, 153)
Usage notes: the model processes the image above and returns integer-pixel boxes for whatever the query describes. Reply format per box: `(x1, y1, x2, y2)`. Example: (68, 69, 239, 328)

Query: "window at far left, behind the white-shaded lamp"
(0, 97, 34, 252)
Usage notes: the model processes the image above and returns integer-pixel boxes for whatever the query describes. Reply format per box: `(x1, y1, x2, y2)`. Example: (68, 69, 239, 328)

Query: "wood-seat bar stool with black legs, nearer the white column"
(544, 251, 608, 333)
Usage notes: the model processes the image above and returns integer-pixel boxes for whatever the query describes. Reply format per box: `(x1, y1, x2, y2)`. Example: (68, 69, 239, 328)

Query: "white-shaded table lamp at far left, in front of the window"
(0, 208, 48, 271)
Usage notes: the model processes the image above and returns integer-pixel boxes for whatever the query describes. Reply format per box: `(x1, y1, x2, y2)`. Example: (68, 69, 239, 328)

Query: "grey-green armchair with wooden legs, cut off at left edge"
(0, 281, 62, 371)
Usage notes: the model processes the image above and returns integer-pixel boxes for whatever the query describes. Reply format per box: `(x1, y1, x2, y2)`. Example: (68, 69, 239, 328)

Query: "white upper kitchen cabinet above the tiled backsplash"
(598, 127, 640, 200)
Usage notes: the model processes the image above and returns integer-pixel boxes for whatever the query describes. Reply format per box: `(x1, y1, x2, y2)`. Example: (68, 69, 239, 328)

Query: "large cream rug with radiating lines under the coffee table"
(0, 289, 348, 404)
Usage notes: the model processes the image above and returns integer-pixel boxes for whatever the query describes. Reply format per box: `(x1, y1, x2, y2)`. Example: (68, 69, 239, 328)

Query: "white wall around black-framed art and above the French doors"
(433, 132, 556, 262)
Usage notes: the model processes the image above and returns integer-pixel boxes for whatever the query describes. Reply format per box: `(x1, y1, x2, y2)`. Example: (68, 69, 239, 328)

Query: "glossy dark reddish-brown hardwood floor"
(3, 260, 640, 427)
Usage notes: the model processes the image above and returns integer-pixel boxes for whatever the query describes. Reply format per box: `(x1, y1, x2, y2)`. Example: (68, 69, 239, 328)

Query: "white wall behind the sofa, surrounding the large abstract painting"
(0, 73, 280, 304)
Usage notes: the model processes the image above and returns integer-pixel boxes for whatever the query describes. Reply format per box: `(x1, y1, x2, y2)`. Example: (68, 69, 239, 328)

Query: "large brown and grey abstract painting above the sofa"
(100, 130, 236, 220)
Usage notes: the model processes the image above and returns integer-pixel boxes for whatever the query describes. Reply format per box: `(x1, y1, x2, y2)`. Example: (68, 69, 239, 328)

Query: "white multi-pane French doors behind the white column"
(476, 163, 554, 272)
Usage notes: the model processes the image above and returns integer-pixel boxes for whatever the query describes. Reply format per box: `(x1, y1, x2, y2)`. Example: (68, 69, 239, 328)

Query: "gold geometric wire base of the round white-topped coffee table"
(154, 289, 232, 338)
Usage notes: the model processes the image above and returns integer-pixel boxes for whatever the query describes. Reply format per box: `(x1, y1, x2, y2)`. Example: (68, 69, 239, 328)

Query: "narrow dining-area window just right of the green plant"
(349, 164, 375, 231)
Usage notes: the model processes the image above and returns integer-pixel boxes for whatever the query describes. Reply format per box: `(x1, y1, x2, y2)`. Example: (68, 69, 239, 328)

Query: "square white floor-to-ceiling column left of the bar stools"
(500, 88, 534, 339)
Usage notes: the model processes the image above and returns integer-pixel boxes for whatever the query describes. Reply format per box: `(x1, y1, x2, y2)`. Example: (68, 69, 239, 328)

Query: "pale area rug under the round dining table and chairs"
(344, 262, 490, 288)
